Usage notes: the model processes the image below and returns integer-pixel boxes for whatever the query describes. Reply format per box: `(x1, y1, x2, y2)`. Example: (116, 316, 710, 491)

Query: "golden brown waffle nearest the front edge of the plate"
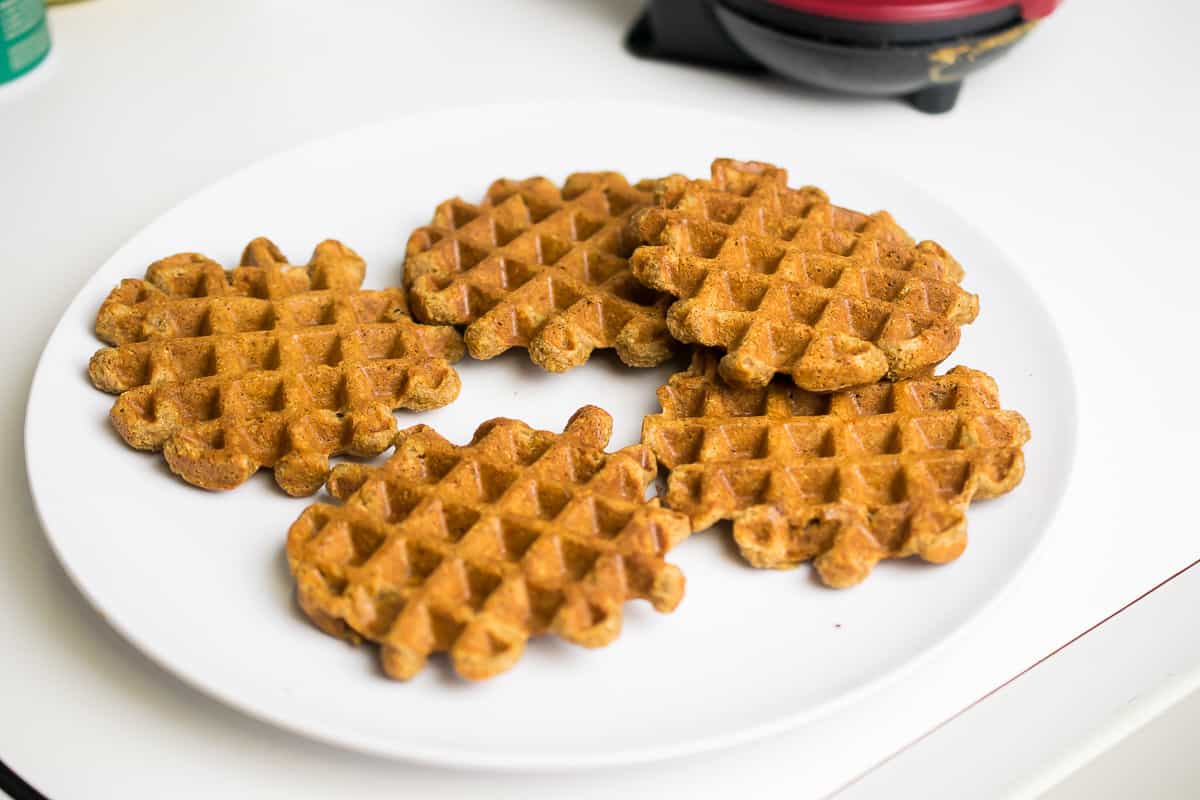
(288, 405, 690, 680)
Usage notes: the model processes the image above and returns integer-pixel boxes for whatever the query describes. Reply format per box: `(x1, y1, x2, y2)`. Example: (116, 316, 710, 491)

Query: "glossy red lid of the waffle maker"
(767, 0, 1058, 23)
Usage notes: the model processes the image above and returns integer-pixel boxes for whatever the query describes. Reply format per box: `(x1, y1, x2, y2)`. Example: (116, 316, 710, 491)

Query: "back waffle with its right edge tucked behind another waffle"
(404, 173, 671, 372)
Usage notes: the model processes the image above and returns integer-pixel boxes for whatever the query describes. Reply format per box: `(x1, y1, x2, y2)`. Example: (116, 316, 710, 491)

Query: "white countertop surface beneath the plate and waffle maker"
(0, 0, 1200, 800)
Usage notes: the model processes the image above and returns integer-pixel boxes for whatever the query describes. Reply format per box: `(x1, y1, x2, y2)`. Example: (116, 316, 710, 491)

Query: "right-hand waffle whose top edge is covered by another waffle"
(642, 351, 1030, 587)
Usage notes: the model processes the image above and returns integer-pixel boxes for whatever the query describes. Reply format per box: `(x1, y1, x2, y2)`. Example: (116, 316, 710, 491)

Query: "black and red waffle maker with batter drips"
(626, 0, 1058, 114)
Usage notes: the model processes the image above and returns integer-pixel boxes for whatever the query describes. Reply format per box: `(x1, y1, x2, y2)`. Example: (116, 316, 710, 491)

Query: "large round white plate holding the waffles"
(26, 107, 1075, 769)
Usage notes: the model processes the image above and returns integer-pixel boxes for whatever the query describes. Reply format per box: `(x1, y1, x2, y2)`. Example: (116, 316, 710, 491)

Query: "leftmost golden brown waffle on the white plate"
(89, 239, 463, 494)
